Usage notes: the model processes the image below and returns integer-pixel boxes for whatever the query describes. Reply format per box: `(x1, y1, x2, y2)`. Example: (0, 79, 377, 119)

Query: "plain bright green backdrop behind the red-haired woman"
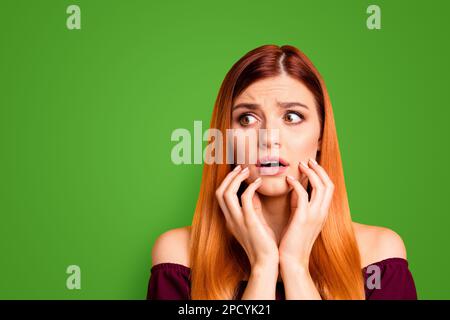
(0, 0, 450, 299)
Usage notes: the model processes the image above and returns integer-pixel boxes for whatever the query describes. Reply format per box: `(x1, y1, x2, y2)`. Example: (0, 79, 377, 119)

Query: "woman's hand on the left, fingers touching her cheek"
(216, 165, 279, 268)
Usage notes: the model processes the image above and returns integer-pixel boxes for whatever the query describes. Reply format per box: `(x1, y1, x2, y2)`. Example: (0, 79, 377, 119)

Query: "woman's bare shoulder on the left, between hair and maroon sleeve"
(152, 226, 191, 267)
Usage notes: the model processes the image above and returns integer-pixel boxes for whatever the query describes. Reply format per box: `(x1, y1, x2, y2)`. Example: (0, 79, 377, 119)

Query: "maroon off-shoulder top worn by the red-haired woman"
(147, 258, 417, 300)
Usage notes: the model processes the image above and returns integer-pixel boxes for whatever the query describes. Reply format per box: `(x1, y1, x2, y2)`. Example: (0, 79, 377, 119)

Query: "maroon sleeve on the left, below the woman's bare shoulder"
(147, 262, 190, 300)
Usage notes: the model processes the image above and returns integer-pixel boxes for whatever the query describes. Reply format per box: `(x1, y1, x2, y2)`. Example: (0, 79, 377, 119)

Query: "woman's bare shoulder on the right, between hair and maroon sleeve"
(353, 222, 407, 267)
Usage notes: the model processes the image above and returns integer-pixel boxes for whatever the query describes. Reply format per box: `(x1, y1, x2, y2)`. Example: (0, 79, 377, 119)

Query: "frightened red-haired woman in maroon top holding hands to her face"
(148, 45, 417, 299)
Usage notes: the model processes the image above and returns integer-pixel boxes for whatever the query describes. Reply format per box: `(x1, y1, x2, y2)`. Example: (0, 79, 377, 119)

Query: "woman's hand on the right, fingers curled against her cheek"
(279, 159, 334, 270)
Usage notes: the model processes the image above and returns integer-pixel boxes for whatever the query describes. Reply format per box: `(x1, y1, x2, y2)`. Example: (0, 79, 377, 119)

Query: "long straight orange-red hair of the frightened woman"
(190, 45, 364, 300)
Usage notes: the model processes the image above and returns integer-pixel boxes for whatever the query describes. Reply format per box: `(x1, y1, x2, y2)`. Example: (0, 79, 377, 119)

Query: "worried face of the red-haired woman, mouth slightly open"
(231, 75, 321, 196)
